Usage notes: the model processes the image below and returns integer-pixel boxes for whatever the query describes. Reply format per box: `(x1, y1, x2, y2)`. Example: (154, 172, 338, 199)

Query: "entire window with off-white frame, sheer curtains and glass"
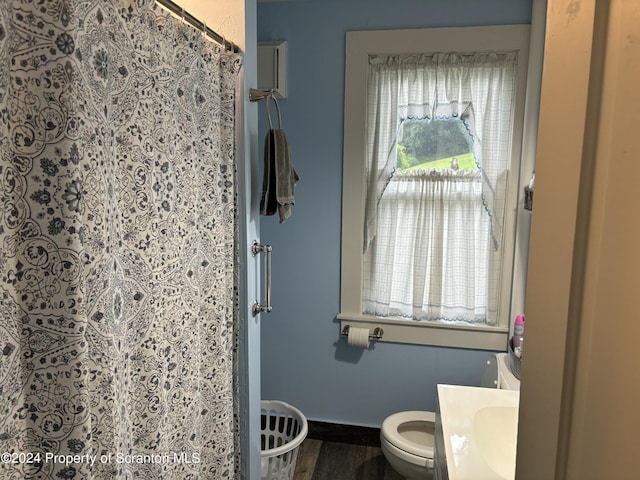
(339, 26, 528, 349)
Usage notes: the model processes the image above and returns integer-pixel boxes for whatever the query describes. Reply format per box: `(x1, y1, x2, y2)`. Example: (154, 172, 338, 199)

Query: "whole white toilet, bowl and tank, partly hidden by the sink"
(380, 353, 520, 480)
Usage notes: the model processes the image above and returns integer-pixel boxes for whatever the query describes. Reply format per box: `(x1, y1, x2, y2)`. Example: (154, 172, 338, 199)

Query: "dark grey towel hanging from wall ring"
(260, 93, 300, 223)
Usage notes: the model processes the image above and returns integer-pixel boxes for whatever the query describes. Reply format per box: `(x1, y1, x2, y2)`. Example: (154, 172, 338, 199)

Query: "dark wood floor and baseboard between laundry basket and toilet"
(293, 424, 403, 480)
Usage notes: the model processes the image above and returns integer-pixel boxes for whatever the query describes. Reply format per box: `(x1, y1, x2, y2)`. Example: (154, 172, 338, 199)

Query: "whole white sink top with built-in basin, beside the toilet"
(436, 385, 520, 480)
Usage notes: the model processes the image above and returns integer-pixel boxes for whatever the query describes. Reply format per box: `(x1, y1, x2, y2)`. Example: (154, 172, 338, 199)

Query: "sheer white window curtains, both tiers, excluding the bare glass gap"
(363, 52, 517, 324)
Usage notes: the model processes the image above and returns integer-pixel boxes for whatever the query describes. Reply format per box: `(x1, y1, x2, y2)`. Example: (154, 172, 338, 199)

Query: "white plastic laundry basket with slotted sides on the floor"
(260, 400, 308, 480)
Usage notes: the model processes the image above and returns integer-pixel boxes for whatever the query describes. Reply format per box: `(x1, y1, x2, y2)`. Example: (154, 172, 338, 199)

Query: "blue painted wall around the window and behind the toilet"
(258, 0, 531, 427)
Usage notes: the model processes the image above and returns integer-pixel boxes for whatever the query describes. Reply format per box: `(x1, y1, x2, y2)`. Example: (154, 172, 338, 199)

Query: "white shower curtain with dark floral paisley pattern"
(0, 0, 241, 480)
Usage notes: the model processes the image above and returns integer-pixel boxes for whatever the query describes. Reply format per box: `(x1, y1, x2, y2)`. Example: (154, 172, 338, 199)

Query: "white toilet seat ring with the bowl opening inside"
(382, 411, 436, 458)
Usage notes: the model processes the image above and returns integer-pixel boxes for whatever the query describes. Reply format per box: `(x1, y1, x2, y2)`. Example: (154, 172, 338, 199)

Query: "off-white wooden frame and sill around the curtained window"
(338, 25, 534, 350)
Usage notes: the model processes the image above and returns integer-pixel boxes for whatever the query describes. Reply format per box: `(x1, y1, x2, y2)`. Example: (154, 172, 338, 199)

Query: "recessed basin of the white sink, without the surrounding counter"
(473, 406, 518, 479)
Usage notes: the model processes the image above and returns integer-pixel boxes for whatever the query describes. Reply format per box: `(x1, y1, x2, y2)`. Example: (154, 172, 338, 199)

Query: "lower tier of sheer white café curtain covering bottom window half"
(365, 171, 489, 322)
